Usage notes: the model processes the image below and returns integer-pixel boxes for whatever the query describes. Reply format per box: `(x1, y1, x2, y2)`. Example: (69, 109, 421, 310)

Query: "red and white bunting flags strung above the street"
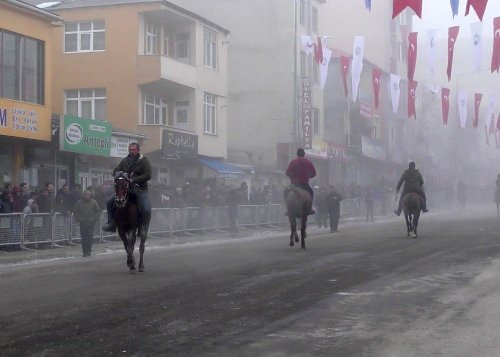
(301, 0, 500, 146)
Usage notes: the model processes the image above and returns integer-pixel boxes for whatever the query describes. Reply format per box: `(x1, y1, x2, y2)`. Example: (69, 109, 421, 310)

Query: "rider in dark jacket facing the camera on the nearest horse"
(102, 143, 151, 237)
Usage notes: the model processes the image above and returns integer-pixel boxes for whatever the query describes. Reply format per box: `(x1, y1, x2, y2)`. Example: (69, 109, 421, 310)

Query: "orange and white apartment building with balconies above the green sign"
(25, 0, 232, 187)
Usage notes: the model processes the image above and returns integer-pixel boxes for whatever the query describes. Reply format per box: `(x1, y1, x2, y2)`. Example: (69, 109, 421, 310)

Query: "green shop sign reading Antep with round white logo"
(59, 115, 112, 157)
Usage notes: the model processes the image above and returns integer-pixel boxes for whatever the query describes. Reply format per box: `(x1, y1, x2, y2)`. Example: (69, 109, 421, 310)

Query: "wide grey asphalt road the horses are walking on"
(0, 206, 500, 356)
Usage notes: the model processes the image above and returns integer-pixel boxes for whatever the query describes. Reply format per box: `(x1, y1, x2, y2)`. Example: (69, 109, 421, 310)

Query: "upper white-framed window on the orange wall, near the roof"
(64, 20, 105, 53)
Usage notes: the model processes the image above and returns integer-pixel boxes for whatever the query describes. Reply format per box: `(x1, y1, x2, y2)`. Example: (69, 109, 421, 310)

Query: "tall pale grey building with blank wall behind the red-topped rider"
(166, 0, 325, 186)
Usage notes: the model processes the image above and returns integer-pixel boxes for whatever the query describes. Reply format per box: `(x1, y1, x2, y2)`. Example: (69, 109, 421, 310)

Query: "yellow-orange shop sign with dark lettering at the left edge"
(0, 102, 51, 141)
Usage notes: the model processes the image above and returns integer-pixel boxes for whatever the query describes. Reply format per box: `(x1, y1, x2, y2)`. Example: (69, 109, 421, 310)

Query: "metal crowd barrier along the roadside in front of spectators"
(0, 199, 374, 249)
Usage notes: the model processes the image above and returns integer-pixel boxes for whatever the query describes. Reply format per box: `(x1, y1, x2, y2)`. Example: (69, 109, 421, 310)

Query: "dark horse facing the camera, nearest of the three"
(114, 172, 146, 273)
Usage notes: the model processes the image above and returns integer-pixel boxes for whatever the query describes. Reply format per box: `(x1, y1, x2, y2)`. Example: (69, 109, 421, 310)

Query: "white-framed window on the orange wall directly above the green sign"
(65, 88, 107, 120)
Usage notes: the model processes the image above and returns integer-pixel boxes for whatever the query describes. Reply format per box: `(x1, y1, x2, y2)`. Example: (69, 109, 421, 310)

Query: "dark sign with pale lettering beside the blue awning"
(161, 129, 198, 159)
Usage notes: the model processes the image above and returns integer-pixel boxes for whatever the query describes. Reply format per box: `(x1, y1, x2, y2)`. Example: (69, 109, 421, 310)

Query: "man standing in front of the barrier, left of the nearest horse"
(73, 190, 101, 257)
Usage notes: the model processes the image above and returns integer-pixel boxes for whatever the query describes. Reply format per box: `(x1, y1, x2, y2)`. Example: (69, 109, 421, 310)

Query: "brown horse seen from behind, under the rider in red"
(283, 185, 311, 249)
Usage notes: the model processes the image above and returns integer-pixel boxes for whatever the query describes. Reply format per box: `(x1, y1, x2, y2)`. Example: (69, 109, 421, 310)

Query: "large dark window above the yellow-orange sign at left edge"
(0, 30, 45, 104)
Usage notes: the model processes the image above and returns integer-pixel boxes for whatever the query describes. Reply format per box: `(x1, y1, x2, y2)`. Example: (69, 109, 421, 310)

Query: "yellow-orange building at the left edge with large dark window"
(0, 0, 62, 186)
